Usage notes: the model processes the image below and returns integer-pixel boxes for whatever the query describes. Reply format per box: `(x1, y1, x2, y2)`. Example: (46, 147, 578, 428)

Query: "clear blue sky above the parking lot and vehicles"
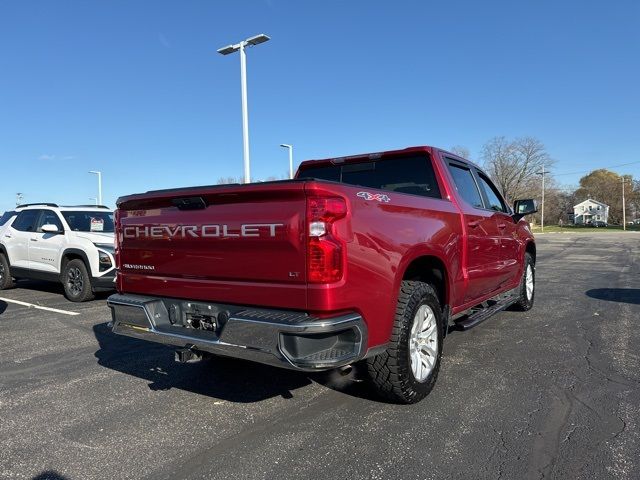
(0, 0, 640, 212)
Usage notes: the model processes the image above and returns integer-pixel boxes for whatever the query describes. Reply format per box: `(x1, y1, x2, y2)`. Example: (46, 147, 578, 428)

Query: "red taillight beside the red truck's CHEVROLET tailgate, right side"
(307, 197, 347, 283)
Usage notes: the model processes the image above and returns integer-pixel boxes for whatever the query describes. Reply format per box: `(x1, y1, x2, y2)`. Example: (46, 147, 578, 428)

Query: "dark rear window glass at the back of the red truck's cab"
(299, 155, 442, 198)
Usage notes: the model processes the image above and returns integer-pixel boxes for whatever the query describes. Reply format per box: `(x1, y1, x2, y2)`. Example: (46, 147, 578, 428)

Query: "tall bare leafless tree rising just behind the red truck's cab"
(482, 137, 553, 202)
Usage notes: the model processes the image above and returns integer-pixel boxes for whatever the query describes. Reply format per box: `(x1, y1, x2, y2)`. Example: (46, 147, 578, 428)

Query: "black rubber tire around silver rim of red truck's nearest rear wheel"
(367, 281, 443, 403)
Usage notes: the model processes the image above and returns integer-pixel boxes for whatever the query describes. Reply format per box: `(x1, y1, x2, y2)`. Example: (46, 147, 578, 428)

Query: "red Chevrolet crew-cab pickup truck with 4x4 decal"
(108, 147, 536, 403)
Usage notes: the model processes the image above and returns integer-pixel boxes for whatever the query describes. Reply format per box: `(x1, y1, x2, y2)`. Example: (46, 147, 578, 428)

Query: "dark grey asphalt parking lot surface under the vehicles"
(0, 233, 640, 479)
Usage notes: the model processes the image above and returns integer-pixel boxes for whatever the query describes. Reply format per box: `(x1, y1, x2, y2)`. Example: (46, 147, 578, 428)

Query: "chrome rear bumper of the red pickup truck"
(107, 294, 367, 371)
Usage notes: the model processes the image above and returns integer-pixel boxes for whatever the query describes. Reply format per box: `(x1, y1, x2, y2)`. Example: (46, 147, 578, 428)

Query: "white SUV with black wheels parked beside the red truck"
(0, 203, 115, 302)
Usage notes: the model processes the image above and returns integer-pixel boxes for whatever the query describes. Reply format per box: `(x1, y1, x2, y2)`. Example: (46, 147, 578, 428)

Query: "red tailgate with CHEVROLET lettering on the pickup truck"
(117, 181, 306, 308)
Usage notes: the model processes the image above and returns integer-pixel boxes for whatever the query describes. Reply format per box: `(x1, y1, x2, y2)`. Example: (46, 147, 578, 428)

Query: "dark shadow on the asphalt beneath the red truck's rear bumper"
(93, 323, 374, 403)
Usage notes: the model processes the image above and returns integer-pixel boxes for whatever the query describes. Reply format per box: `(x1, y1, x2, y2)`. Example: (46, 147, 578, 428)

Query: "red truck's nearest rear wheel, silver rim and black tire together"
(367, 281, 443, 403)
